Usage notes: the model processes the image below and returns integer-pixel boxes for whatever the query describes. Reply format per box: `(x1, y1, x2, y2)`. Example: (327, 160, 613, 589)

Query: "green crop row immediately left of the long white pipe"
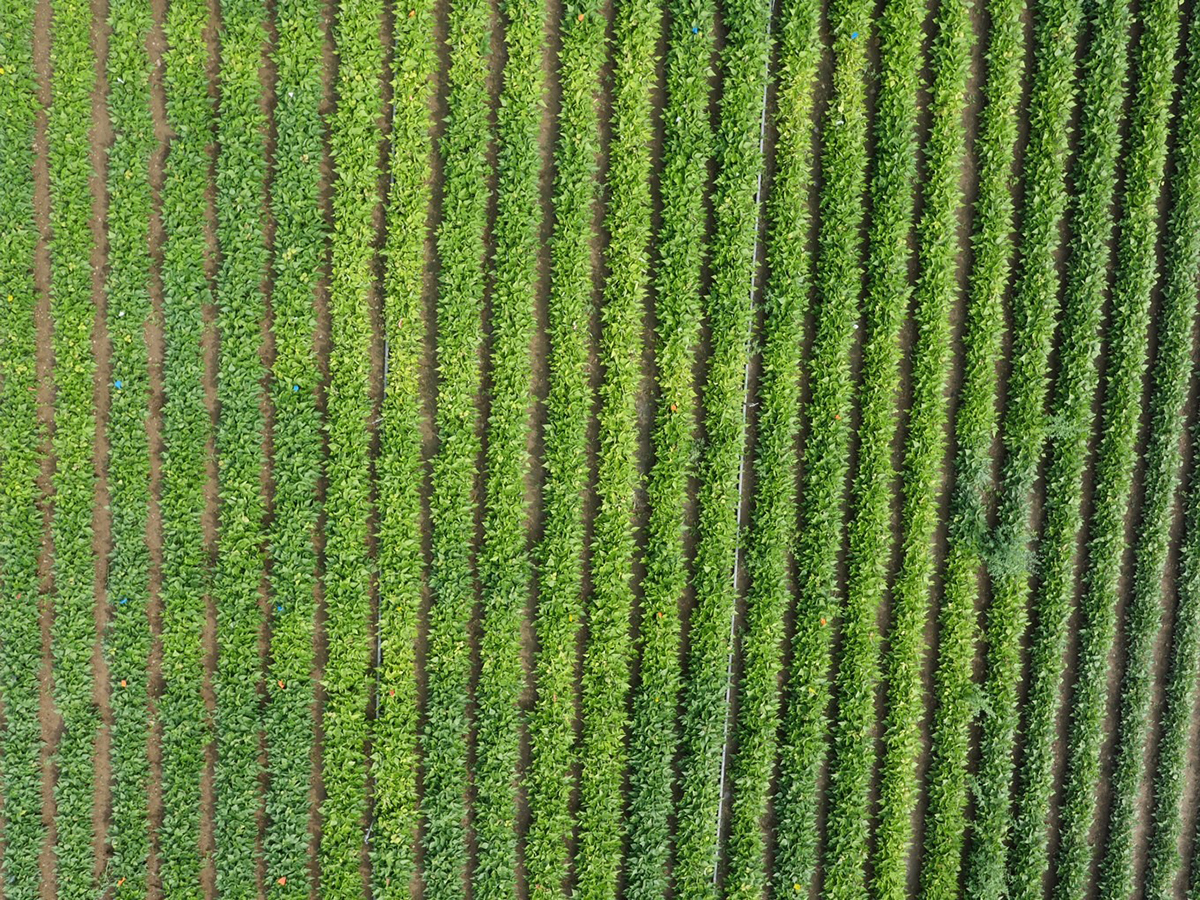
(674, 0, 773, 898)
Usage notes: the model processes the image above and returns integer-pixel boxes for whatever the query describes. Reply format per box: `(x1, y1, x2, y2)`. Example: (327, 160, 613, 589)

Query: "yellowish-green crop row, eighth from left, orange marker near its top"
(371, 0, 437, 900)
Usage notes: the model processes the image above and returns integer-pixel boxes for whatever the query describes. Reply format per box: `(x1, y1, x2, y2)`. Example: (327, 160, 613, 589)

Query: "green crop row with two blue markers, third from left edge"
(104, 0, 156, 898)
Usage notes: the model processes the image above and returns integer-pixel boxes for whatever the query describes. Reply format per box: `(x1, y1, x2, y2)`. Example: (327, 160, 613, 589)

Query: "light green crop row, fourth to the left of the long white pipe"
(524, 0, 607, 900)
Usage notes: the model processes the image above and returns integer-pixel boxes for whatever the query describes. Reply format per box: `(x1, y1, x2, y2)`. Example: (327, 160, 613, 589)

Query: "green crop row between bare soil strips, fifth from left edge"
(212, 0, 268, 900)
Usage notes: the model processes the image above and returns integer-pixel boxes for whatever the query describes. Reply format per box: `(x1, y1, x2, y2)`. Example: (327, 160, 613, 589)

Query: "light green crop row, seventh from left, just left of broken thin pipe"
(319, 0, 384, 899)
